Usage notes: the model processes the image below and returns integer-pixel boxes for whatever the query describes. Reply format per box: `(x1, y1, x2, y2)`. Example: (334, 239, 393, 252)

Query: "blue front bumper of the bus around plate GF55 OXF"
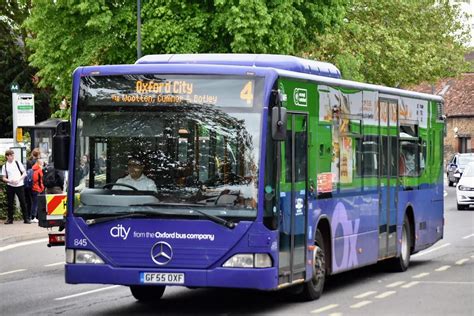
(65, 264, 278, 290)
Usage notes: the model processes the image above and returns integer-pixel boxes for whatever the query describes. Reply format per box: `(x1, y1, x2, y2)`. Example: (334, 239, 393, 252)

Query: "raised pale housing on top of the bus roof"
(135, 54, 341, 78)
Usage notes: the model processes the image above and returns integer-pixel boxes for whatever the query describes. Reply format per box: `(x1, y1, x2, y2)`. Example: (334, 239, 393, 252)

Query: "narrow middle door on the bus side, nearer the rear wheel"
(378, 99, 399, 258)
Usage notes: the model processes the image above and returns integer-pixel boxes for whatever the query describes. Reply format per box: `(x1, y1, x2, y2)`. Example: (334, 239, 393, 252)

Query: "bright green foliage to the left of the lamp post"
(25, 0, 135, 104)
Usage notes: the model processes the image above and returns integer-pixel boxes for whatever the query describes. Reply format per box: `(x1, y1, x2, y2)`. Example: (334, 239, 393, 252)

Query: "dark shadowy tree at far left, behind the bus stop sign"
(0, 0, 49, 137)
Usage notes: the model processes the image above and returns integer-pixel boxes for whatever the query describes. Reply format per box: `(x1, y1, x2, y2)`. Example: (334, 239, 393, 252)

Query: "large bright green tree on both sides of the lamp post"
(25, 0, 348, 103)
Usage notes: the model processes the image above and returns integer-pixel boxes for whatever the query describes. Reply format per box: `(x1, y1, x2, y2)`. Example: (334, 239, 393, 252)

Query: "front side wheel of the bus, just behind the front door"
(301, 230, 326, 301)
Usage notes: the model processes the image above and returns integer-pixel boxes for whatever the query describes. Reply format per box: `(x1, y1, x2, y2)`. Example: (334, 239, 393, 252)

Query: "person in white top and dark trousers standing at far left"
(2, 149, 31, 224)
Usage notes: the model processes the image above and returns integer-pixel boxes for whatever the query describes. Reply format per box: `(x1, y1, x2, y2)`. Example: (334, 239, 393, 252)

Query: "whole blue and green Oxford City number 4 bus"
(60, 54, 444, 301)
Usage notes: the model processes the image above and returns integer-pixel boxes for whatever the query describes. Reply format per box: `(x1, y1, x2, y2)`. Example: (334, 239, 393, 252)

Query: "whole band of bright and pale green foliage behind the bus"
(23, 0, 468, 105)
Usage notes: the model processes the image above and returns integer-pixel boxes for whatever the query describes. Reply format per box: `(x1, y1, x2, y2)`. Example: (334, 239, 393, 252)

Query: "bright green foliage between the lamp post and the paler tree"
(139, 0, 347, 54)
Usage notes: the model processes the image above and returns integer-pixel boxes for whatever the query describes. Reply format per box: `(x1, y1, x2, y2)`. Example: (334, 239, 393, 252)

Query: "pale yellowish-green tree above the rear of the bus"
(306, 0, 468, 86)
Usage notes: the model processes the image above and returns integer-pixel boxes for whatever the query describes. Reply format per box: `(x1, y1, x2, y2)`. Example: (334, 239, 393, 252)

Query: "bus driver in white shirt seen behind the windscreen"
(113, 158, 158, 192)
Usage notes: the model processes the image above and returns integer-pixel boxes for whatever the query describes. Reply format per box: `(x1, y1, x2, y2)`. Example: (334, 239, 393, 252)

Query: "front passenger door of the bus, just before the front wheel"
(279, 113, 308, 284)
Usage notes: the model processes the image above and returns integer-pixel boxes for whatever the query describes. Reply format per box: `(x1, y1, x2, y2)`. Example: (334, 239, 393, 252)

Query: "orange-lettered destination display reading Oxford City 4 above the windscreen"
(81, 75, 262, 108)
